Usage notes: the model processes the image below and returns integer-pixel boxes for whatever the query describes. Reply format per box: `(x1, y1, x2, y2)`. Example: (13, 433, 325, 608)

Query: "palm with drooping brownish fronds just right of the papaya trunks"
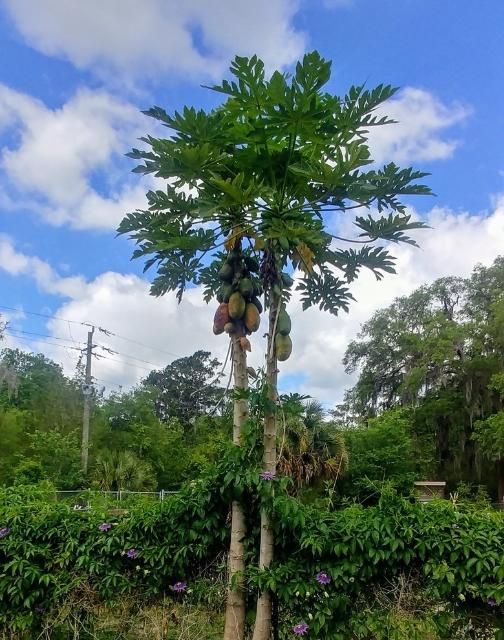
(278, 394, 348, 492)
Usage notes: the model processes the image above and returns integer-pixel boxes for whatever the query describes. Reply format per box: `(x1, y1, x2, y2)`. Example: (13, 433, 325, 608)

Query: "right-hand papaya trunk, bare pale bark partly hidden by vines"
(253, 299, 280, 640)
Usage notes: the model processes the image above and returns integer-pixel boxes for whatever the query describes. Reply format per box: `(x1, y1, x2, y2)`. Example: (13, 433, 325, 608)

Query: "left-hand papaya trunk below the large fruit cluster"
(224, 334, 249, 640)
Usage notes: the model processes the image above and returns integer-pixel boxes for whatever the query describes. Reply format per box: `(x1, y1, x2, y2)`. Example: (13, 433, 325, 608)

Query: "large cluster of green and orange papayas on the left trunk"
(213, 249, 262, 336)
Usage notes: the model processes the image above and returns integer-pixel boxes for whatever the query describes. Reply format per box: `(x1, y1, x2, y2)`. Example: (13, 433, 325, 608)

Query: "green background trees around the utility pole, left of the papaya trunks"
(0, 349, 230, 490)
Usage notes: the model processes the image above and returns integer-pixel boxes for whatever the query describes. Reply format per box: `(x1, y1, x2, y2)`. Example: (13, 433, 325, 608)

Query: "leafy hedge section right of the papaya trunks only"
(262, 493, 504, 640)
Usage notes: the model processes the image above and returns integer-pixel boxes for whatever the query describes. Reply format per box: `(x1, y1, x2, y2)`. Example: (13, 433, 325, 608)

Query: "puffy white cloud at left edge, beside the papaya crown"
(0, 85, 148, 229)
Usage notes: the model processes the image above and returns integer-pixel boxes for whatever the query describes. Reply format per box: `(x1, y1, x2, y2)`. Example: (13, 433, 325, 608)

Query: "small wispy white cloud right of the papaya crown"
(369, 87, 471, 164)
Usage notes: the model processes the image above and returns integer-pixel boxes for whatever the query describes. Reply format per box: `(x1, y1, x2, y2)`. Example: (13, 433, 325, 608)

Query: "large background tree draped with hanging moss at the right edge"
(344, 257, 504, 500)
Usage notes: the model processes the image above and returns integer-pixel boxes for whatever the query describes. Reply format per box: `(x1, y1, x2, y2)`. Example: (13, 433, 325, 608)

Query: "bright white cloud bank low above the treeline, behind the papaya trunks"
(0, 198, 504, 404)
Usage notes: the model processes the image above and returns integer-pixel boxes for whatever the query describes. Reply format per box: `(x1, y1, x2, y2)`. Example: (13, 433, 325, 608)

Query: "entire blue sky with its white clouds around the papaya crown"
(0, 0, 504, 402)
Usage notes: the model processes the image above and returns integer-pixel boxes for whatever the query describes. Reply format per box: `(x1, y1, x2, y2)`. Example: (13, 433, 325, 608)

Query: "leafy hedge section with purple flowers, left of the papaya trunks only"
(0, 481, 227, 631)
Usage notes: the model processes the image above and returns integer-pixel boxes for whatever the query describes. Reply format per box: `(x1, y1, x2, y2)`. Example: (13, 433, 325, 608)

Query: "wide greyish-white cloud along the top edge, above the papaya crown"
(4, 0, 304, 81)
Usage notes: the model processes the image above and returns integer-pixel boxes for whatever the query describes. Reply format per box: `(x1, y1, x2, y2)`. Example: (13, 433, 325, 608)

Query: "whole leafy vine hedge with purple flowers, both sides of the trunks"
(0, 476, 504, 640)
